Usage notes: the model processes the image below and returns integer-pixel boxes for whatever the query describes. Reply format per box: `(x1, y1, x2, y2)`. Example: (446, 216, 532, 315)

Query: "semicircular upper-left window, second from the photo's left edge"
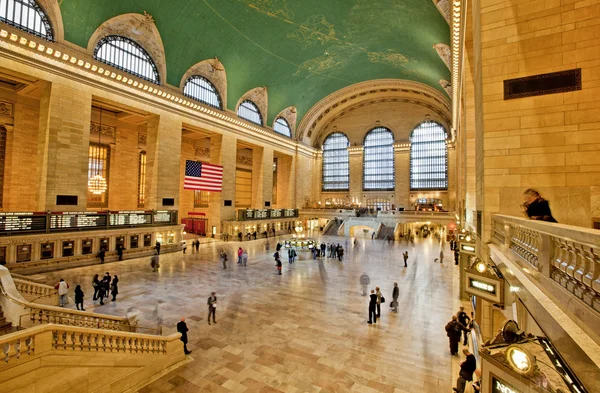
(94, 35, 160, 84)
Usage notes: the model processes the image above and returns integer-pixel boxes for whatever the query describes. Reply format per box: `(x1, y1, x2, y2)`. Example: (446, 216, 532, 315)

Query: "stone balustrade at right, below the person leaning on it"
(492, 215, 600, 312)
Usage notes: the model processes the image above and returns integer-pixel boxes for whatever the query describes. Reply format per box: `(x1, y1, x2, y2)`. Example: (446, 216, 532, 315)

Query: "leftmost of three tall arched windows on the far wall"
(323, 132, 350, 191)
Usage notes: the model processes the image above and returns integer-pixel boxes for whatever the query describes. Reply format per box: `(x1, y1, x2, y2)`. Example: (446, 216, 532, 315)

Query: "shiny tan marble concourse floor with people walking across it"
(28, 237, 458, 393)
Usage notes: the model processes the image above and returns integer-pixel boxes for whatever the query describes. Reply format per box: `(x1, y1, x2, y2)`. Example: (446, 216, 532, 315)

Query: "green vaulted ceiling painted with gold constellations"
(61, 0, 450, 124)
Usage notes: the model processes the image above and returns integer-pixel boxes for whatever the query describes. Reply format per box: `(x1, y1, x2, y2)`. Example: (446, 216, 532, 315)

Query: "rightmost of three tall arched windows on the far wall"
(410, 121, 448, 191)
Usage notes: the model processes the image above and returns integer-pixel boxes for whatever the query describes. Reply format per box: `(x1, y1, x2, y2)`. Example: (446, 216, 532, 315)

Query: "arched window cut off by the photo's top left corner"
(0, 0, 54, 41)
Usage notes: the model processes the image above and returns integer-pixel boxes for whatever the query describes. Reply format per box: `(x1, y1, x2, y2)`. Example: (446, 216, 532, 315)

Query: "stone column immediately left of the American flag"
(144, 114, 183, 210)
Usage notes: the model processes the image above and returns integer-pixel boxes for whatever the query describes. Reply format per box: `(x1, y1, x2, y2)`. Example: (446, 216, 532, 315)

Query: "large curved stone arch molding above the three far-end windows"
(297, 79, 451, 146)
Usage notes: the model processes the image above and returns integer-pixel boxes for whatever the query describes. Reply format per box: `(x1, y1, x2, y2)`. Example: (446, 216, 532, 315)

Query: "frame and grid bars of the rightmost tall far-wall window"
(409, 120, 448, 191)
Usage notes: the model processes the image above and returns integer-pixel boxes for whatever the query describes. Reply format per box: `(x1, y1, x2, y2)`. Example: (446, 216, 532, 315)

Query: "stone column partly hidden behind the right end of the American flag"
(207, 135, 237, 233)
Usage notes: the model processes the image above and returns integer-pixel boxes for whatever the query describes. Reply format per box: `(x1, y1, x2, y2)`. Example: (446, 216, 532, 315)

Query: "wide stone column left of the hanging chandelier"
(36, 82, 92, 211)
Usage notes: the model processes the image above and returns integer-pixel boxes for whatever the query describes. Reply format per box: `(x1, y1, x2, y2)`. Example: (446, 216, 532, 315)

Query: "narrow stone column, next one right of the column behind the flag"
(252, 146, 273, 209)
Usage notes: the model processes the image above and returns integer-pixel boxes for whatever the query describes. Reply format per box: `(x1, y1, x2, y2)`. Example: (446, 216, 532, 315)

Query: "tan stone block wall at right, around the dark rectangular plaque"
(466, 0, 600, 231)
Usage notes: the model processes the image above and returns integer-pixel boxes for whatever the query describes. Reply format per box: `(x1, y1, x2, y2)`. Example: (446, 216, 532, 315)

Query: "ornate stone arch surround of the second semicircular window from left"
(87, 11, 167, 81)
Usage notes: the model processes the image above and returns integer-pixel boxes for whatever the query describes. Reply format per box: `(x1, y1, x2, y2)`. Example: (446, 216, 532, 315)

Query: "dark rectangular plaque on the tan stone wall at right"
(504, 68, 581, 100)
